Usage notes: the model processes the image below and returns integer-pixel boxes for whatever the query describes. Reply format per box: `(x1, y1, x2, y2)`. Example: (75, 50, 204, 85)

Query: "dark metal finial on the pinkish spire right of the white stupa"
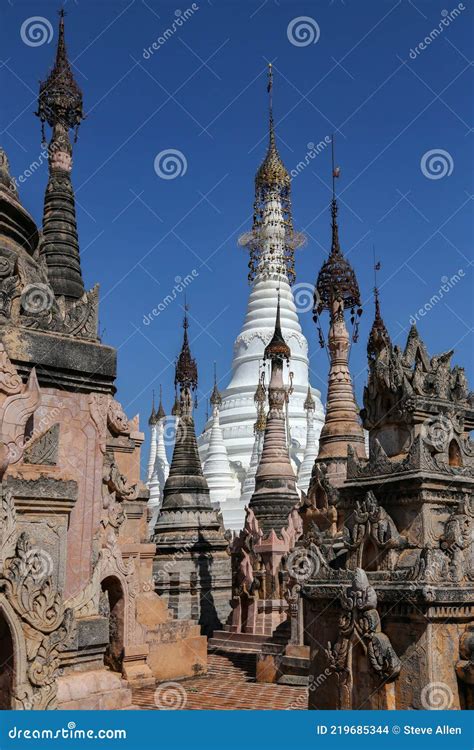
(313, 141, 362, 322)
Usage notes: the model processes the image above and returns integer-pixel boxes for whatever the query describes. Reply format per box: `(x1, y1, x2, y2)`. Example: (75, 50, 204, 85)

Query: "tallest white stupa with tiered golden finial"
(198, 66, 324, 528)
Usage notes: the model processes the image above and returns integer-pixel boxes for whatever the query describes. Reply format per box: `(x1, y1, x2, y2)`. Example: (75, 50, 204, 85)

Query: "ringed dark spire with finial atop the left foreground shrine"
(36, 10, 85, 299)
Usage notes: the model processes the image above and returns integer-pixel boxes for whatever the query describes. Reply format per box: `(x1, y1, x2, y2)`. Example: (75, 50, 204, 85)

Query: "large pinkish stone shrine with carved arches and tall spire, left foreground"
(0, 14, 206, 709)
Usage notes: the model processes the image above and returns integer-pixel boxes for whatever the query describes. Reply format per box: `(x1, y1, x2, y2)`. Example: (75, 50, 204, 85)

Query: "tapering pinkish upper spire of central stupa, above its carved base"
(249, 298, 299, 534)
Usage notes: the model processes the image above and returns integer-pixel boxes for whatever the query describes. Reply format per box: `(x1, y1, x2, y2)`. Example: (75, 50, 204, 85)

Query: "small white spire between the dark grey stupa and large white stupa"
(203, 365, 236, 503)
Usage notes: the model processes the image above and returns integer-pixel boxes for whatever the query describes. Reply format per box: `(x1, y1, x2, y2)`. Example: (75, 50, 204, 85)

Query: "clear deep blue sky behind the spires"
(0, 0, 474, 476)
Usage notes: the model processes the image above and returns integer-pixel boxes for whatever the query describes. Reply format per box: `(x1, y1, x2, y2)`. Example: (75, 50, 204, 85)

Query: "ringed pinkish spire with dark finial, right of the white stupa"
(313, 143, 366, 478)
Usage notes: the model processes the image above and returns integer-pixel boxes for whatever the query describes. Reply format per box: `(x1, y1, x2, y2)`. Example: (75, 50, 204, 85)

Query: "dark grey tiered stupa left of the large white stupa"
(153, 314, 231, 634)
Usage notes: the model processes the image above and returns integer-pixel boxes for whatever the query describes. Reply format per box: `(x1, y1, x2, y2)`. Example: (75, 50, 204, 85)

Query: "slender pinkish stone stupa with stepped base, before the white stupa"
(210, 300, 307, 683)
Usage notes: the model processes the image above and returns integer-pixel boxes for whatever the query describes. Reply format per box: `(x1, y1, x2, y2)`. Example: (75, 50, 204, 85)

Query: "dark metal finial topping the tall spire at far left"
(36, 9, 84, 142)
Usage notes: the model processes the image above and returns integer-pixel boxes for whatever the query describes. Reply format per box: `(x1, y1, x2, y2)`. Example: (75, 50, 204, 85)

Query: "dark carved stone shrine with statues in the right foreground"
(303, 293, 474, 709)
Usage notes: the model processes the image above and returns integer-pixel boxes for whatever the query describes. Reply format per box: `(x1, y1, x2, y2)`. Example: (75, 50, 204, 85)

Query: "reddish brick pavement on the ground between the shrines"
(133, 653, 308, 711)
